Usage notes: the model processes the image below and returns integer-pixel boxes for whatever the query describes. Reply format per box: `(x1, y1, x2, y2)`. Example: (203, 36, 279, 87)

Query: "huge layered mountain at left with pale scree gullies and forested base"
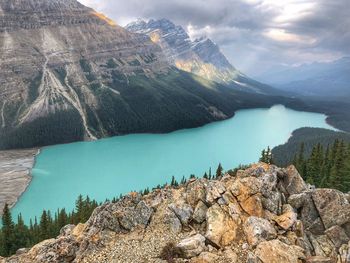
(0, 0, 288, 149)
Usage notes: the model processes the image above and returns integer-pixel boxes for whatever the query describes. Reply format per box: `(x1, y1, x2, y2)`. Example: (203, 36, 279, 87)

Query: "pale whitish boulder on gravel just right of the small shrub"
(176, 234, 206, 258)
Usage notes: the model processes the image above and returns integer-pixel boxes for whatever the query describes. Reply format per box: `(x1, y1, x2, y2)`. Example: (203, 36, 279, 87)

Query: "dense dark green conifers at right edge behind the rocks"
(293, 140, 350, 192)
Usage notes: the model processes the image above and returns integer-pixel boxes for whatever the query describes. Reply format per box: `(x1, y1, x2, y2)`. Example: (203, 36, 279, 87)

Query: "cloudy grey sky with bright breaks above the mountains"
(80, 0, 350, 76)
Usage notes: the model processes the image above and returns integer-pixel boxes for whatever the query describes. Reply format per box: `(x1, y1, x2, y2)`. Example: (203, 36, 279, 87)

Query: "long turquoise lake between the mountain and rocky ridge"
(12, 105, 333, 222)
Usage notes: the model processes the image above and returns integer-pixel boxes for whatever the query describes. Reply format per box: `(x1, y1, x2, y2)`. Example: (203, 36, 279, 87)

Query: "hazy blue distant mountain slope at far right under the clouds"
(256, 57, 350, 101)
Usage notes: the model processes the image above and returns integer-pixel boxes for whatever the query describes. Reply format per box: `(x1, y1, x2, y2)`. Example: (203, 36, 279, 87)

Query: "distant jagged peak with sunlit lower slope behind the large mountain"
(125, 18, 277, 94)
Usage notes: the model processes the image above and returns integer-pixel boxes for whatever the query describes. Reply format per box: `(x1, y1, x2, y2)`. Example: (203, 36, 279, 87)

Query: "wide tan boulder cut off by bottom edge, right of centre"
(255, 239, 305, 263)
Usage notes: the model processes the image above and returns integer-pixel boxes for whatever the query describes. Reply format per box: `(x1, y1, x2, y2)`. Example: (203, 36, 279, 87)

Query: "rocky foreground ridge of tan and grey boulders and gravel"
(0, 163, 350, 263)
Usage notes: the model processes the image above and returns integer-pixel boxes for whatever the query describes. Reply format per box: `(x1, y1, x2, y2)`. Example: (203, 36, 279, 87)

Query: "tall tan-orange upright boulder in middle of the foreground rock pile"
(205, 204, 239, 246)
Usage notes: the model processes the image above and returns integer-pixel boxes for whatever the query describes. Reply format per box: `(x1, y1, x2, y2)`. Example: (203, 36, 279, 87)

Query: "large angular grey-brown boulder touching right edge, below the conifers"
(312, 189, 350, 229)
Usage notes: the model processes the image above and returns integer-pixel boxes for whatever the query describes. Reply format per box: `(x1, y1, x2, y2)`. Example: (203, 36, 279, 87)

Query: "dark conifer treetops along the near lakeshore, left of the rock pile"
(0, 164, 224, 257)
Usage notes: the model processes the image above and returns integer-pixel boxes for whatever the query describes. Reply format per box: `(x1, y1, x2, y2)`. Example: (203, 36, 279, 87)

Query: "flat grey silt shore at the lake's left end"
(0, 148, 40, 216)
